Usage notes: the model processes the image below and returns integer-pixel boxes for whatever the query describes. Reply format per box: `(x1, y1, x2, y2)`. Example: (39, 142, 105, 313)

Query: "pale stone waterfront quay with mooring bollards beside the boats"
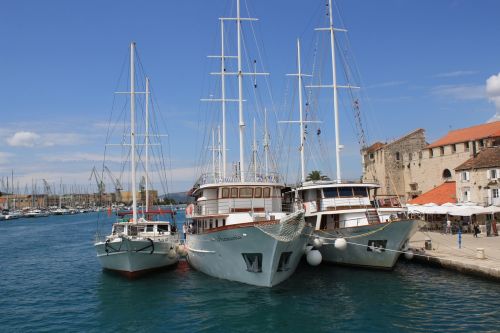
(410, 231, 500, 281)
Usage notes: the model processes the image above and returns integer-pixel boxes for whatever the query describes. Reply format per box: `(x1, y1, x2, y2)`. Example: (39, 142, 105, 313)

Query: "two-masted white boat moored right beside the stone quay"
(286, 0, 420, 269)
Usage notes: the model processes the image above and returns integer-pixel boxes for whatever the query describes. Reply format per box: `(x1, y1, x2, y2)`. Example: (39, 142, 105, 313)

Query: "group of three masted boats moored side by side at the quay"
(95, 0, 419, 287)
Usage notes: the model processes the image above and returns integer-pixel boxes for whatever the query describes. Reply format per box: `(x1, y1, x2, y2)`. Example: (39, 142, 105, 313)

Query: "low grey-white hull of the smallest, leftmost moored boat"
(95, 237, 179, 275)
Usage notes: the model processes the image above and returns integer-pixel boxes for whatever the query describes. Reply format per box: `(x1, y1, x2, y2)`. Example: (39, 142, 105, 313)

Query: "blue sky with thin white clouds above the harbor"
(0, 0, 500, 191)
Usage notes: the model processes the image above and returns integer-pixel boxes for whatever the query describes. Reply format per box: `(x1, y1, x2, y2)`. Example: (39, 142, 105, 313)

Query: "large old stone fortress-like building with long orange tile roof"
(363, 121, 500, 201)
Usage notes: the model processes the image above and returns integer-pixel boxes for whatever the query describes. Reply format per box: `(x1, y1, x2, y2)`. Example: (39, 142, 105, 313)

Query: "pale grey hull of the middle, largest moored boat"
(186, 217, 310, 287)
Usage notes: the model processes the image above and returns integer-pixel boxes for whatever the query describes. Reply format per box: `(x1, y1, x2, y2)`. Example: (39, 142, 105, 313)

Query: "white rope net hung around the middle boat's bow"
(255, 210, 306, 243)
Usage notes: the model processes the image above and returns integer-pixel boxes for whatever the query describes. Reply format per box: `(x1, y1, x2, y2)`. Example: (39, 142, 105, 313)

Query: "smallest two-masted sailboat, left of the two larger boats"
(94, 43, 179, 277)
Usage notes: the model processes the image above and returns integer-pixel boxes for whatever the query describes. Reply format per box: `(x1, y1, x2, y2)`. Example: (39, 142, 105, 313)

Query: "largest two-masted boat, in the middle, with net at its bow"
(186, 0, 310, 287)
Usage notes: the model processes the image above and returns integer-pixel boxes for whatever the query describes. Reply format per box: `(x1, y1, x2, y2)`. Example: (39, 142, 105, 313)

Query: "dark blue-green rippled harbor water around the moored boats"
(0, 213, 500, 332)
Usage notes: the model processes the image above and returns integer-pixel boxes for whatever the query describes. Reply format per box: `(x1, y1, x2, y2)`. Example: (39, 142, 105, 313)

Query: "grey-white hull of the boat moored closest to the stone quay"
(315, 220, 419, 269)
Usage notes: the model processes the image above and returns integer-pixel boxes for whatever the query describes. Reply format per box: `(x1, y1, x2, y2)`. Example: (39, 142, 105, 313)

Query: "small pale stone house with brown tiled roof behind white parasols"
(455, 146, 500, 206)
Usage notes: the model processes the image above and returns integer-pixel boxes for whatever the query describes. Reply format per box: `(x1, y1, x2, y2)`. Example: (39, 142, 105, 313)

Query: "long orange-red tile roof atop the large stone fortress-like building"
(426, 121, 500, 148)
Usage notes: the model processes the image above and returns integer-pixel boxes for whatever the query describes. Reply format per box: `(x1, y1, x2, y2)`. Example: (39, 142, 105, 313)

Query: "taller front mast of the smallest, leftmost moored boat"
(130, 42, 137, 223)
